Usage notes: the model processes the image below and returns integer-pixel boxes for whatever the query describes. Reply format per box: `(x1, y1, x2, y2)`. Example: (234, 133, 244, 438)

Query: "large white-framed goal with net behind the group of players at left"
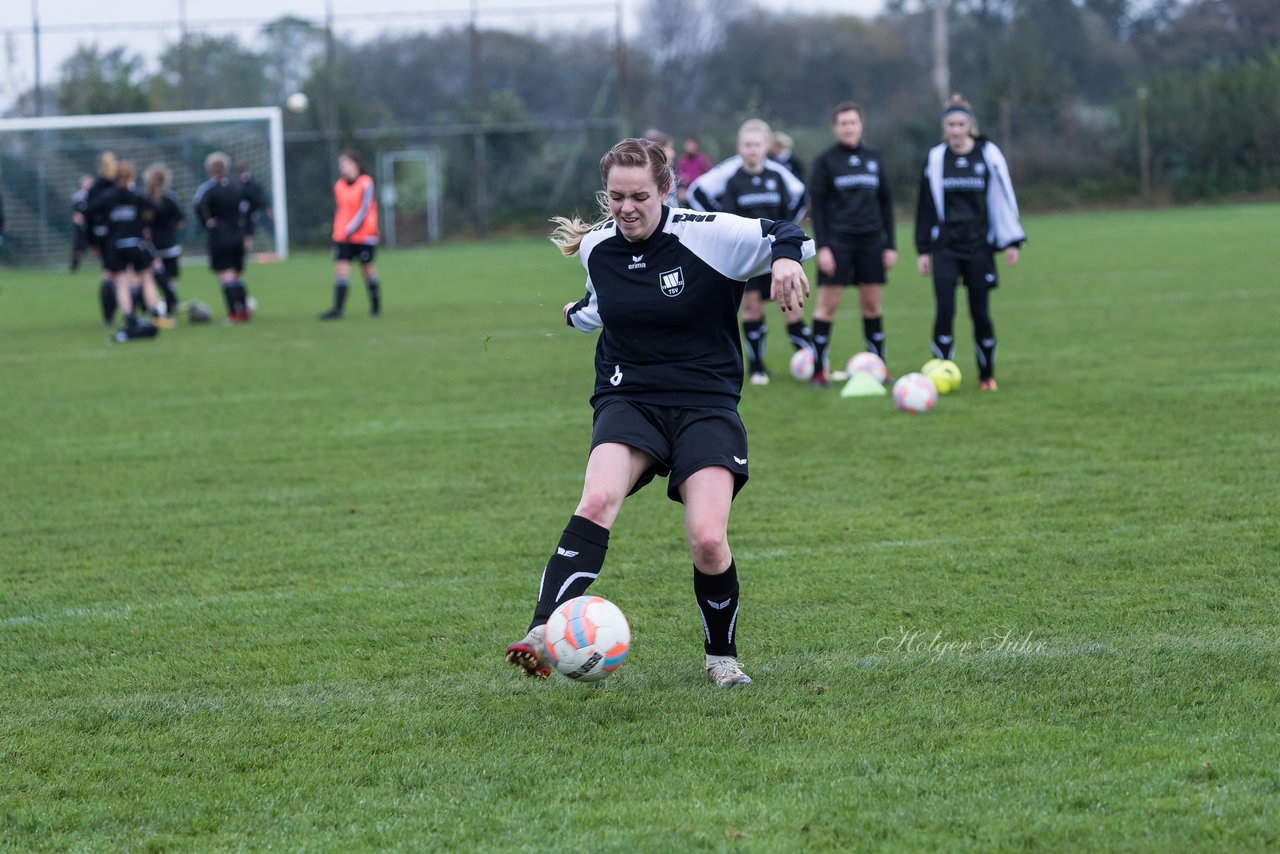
(0, 106, 289, 265)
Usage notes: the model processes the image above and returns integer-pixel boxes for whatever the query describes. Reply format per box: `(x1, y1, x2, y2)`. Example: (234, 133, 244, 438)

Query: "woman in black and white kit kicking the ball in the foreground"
(507, 140, 813, 688)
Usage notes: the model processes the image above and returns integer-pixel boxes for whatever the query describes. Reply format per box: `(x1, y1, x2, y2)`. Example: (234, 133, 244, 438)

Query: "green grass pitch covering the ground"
(0, 206, 1280, 851)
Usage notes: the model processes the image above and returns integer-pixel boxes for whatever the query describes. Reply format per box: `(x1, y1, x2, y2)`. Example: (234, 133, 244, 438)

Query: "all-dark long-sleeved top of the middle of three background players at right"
(809, 142, 895, 250)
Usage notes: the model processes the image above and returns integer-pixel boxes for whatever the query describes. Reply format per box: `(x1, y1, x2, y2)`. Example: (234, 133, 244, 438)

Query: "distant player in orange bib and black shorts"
(320, 151, 383, 320)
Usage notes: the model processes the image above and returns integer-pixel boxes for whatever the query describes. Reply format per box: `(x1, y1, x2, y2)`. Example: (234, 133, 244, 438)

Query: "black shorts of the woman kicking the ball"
(591, 398, 750, 502)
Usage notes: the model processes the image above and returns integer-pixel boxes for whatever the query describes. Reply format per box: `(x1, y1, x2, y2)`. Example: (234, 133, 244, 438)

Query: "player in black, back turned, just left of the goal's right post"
(192, 151, 252, 324)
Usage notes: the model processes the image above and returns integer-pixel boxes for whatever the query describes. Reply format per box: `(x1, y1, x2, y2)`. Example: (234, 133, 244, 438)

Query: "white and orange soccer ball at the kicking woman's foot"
(547, 597, 631, 682)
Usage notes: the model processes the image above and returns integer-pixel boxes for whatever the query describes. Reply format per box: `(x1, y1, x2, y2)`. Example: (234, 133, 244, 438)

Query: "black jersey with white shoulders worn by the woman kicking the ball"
(568, 206, 814, 407)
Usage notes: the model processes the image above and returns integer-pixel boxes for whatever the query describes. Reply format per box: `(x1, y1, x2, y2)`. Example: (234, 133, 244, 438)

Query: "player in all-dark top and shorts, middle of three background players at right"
(809, 101, 897, 385)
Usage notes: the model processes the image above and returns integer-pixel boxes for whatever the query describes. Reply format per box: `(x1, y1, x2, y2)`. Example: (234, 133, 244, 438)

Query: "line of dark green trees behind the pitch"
(10, 0, 1280, 240)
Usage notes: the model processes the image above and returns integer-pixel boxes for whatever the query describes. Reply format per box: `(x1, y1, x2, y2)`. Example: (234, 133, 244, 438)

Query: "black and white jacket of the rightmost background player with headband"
(915, 137, 1027, 257)
